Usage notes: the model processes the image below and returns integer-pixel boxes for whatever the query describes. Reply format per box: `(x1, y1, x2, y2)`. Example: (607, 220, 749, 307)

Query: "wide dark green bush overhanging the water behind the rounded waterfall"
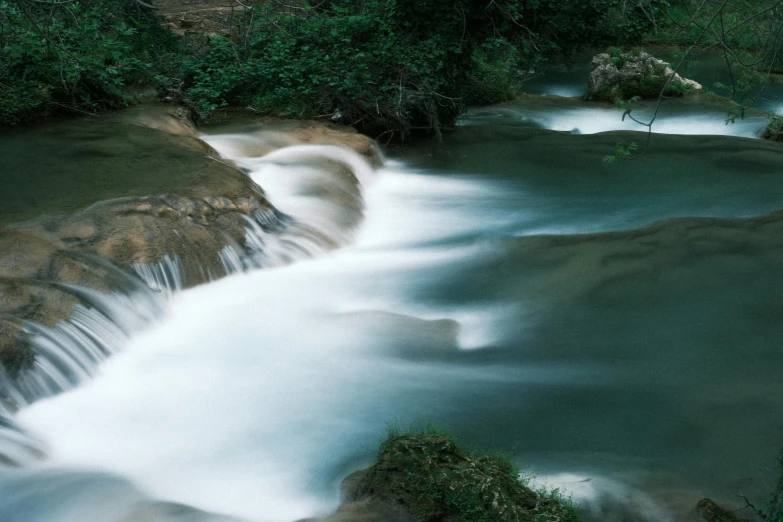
(184, 0, 660, 137)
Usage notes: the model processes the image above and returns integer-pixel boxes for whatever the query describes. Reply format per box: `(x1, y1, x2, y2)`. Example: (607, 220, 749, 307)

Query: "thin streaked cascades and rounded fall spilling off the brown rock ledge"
(0, 140, 380, 466)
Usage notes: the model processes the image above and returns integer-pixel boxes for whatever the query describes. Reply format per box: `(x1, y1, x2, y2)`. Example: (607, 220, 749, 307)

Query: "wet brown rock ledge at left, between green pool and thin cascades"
(0, 191, 275, 372)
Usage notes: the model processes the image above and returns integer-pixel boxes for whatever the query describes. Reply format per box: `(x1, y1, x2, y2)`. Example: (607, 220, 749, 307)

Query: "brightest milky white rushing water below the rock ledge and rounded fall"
(12, 143, 540, 521)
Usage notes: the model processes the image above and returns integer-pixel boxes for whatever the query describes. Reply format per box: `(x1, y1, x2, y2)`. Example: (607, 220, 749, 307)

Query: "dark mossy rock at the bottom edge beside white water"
(311, 435, 576, 522)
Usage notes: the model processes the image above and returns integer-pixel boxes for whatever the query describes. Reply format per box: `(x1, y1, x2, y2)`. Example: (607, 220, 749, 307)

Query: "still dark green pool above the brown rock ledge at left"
(0, 107, 239, 225)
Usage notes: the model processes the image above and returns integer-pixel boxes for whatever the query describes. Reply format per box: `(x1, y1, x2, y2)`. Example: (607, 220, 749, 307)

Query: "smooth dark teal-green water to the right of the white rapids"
(376, 125, 783, 517)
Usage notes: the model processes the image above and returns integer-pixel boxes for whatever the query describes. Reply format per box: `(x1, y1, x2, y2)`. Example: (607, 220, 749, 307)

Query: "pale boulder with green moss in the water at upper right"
(585, 51, 702, 101)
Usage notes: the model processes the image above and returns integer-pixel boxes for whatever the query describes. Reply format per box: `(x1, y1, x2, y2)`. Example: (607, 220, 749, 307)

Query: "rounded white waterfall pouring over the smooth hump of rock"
(203, 141, 375, 274)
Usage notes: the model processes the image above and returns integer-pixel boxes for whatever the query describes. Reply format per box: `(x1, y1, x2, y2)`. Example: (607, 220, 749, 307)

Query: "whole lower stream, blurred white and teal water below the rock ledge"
(0, 65, 783, 522)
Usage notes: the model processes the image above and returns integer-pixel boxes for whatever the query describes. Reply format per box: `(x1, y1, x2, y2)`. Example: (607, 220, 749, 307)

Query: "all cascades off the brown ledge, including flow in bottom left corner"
(0, 133, 382, 522)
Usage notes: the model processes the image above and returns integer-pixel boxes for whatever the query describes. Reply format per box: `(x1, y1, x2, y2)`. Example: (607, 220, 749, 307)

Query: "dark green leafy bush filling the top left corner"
(0, 0, 174, 124)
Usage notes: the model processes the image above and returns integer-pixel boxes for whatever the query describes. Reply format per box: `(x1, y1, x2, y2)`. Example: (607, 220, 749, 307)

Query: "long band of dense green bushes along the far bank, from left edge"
(0, 0, 650, 137)
